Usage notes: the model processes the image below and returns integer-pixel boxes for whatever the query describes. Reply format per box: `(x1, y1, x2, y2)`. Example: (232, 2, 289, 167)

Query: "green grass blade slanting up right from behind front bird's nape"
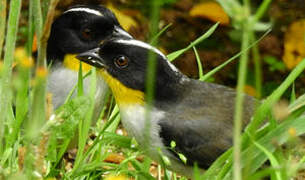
(167, 23, 219, 61)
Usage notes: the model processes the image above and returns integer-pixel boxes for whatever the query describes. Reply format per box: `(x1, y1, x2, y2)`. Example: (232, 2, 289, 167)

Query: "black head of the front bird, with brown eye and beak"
(77, 39, 182, 103)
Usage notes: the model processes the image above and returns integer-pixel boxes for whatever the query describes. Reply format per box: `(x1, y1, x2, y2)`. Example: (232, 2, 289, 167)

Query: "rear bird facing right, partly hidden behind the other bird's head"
(47, 5, 131, 111)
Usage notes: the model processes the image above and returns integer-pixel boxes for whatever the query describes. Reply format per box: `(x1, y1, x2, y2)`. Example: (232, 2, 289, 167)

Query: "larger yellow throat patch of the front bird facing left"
(98, 69, 144, 106)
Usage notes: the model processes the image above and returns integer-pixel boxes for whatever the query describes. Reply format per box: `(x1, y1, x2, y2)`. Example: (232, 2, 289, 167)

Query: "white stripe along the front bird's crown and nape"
(115, 39, 180, 72)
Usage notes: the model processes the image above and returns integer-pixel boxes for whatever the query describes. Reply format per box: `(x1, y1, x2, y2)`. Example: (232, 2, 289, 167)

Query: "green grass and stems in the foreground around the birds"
(0, 0, 305, 180)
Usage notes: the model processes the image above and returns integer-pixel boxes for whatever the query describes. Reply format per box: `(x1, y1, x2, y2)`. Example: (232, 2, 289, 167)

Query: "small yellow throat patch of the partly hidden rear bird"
(63, 54, 92, 73)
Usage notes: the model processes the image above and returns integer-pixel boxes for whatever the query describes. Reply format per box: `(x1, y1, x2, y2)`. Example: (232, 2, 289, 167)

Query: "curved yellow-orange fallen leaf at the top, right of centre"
(190, 2, 230, 25)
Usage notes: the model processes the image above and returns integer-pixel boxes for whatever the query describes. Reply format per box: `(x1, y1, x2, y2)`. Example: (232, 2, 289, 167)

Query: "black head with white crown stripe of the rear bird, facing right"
(47, 5, 131, 63)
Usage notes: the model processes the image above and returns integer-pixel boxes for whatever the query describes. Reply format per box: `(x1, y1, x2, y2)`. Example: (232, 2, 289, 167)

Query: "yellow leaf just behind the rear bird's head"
(107, 3, 138, 31)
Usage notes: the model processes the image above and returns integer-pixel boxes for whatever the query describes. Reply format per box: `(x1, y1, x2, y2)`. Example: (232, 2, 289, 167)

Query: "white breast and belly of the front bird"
(120, 105, 200, 177)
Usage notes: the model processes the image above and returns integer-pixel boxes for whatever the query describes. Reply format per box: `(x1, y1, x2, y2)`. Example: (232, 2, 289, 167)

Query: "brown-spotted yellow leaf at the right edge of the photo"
(283, 19, 305, 69)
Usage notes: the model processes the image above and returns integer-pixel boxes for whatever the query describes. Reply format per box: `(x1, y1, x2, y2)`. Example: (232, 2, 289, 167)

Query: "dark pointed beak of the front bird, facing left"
(76, 48, 105, 68)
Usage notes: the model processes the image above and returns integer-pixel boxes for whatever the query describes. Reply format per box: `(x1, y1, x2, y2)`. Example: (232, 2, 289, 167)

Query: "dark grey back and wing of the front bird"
(159, 81, 257, 168)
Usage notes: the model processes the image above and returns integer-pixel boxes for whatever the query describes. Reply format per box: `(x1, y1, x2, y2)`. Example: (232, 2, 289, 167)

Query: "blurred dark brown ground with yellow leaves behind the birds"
(18, 0, 305, 97)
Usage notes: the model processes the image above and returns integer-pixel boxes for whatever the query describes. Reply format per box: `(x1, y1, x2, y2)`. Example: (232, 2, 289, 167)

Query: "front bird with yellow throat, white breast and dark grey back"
(77, 39, 255, 177)
